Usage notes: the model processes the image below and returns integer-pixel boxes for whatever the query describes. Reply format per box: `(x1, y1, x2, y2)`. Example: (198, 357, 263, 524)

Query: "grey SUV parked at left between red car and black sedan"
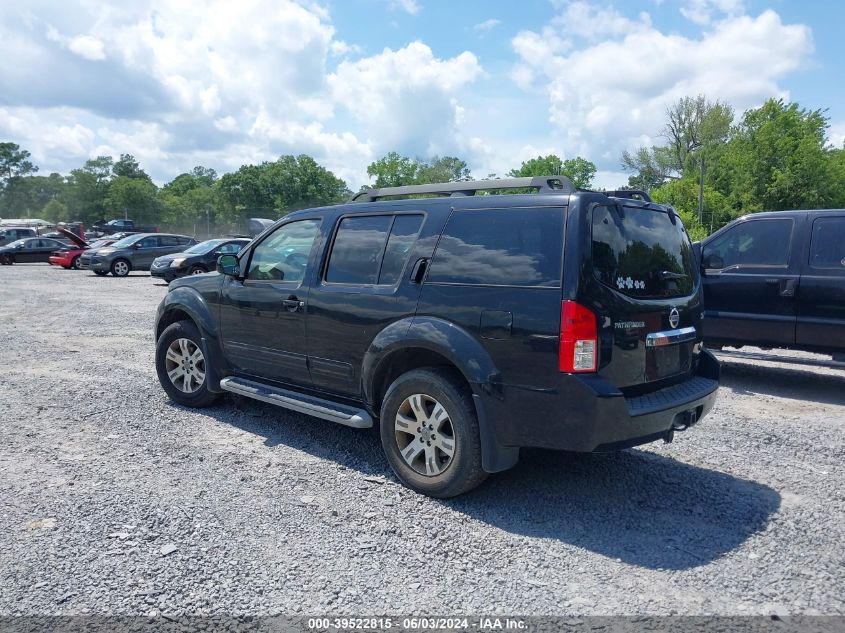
(86, 233, 197, 277)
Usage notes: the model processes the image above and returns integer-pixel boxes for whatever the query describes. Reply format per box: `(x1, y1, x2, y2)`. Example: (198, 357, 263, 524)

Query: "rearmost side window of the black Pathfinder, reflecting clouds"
(426, 207, 563, 287)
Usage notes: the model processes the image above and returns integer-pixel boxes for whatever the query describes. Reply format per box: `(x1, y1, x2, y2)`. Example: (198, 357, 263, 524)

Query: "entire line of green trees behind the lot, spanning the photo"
(0, 96, 845, 238)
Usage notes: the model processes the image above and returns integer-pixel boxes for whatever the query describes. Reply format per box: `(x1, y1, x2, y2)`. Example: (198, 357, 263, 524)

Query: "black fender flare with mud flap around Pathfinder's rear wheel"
(361, 317, 519, 473)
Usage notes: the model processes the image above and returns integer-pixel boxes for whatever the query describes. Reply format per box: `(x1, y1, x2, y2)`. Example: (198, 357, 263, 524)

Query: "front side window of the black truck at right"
(702, 218, 792, 270)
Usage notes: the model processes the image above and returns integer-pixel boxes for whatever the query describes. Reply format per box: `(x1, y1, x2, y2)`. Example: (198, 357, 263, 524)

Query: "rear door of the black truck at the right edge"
(796, 211, 845, 354)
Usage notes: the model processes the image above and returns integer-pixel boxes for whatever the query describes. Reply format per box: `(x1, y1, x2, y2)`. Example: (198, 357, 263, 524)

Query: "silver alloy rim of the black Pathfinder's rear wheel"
(394, 393, 455, 477)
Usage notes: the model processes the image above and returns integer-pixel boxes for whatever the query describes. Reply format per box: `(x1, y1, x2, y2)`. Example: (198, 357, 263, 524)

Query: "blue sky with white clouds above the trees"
(0, 0, 845, 190)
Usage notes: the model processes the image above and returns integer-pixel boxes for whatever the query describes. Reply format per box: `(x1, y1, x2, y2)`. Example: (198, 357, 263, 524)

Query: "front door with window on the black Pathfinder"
(220, 216, 321, 386)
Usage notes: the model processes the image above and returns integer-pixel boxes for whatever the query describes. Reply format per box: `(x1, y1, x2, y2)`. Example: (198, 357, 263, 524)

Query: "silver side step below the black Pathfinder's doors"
(220, 376, 373, 429)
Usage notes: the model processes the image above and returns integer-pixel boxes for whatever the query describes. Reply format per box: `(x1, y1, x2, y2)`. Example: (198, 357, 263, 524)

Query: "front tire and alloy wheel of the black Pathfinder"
(156, 321, 220, 408)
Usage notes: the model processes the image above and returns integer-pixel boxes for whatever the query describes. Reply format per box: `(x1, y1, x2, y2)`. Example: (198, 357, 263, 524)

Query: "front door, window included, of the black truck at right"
(701, 216, 802, 347)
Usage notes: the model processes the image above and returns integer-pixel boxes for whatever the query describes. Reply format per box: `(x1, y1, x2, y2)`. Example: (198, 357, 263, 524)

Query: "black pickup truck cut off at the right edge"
(696, 209, 845, 357)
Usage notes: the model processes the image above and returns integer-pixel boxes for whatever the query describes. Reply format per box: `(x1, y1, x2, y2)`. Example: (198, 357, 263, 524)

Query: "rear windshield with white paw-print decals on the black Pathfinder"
(593, 207, 696, 298)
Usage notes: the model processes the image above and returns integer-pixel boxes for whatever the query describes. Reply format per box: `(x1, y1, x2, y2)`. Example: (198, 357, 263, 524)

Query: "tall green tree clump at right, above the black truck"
(622, 95, 845, 239)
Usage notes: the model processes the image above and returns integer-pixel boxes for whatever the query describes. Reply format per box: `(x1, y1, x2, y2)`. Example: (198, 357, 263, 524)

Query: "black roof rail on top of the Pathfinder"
(349, 176, 576, 202)
